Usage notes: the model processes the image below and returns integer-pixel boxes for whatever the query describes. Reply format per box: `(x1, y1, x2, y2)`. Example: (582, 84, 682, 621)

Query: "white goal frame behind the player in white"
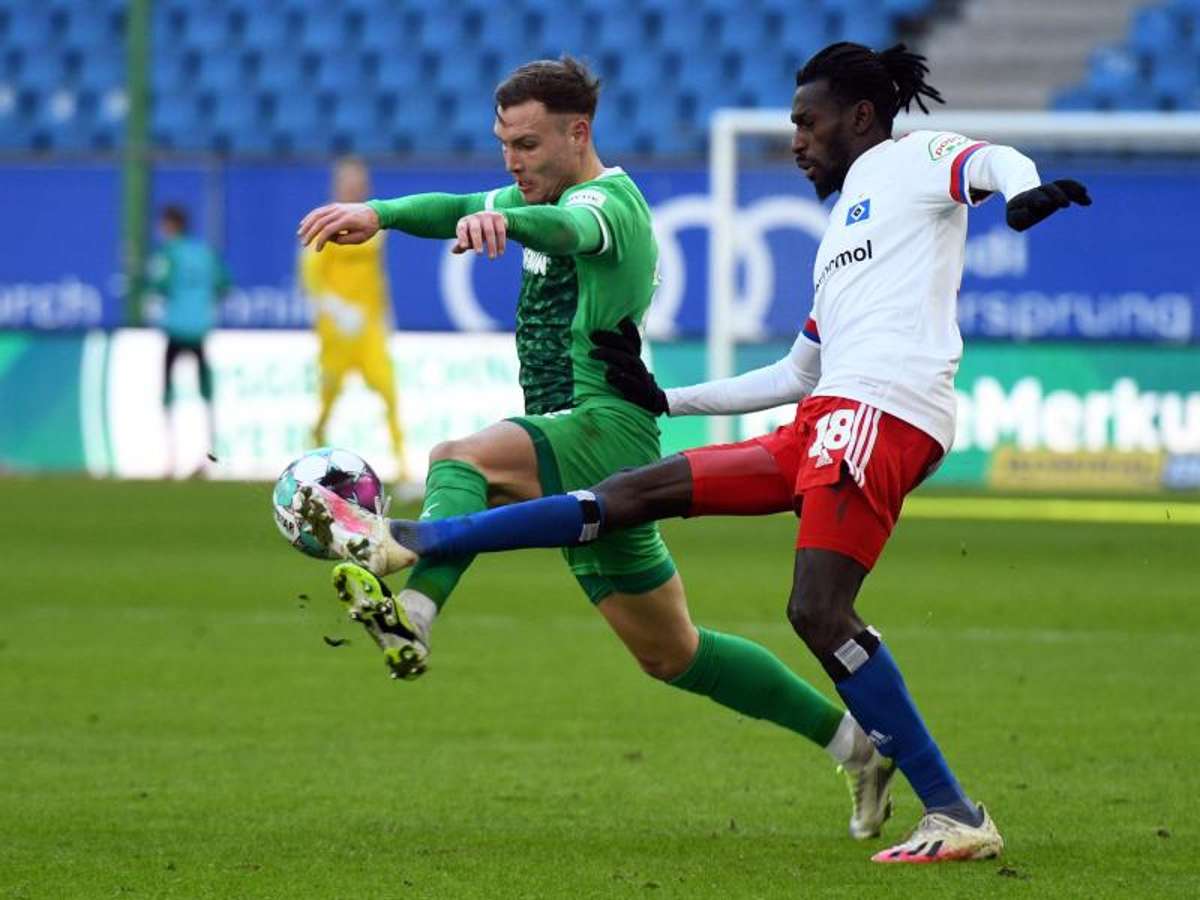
(707, 109, 1200, 443)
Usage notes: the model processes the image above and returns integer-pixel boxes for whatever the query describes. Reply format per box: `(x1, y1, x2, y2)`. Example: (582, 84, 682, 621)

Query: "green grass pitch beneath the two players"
(0, 480, 1200, 900)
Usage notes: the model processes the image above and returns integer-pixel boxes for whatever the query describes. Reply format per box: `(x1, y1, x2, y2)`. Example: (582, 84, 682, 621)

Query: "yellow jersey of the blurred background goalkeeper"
(300, 232, 391, 341)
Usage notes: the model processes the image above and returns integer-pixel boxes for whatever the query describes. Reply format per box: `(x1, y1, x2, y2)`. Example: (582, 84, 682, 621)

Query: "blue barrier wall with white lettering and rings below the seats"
(0, 161, 1200, 342)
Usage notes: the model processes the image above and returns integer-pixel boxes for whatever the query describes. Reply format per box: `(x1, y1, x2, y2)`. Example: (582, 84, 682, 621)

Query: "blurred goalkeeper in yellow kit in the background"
(300, 158, 407, 481)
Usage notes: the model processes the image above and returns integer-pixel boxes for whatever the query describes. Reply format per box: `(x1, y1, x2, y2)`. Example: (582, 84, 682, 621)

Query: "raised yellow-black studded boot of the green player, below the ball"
(334, 563, 432, 682)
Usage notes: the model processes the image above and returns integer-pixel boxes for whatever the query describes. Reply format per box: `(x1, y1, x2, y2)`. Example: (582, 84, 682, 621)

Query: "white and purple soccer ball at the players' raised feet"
(271, 446, 383, 559)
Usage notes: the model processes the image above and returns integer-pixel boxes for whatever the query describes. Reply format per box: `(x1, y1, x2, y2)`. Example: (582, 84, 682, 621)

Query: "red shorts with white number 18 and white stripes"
(684, 397, 942, 569)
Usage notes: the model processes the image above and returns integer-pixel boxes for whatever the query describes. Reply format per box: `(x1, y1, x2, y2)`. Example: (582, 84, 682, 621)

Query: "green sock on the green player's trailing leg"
(670, 628, 845, 748)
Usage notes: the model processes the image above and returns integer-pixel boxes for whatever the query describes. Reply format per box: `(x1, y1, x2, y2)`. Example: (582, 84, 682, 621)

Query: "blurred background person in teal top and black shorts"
(148, 204, 230, 476)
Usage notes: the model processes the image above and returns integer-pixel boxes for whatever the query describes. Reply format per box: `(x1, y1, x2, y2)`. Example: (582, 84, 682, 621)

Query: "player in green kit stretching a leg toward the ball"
(296, 56, 894, 839)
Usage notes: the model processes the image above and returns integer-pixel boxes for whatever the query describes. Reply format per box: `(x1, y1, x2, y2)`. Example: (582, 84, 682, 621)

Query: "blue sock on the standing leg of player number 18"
(824, 628, 983, 824)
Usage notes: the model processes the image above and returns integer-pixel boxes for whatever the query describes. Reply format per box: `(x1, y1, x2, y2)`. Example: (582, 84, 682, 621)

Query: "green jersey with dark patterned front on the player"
(486, 168, 659, 415)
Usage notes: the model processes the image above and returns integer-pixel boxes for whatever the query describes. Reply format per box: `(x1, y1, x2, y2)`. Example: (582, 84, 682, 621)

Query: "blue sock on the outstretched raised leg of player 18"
(390, 491, 604, 559)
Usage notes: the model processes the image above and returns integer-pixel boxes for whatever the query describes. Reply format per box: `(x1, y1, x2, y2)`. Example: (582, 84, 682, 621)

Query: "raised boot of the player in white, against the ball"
(292, 484, 418, 576)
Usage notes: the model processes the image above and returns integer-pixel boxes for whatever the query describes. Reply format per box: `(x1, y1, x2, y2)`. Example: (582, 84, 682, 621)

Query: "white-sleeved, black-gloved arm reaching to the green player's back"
(592, 319, 821, 415)
